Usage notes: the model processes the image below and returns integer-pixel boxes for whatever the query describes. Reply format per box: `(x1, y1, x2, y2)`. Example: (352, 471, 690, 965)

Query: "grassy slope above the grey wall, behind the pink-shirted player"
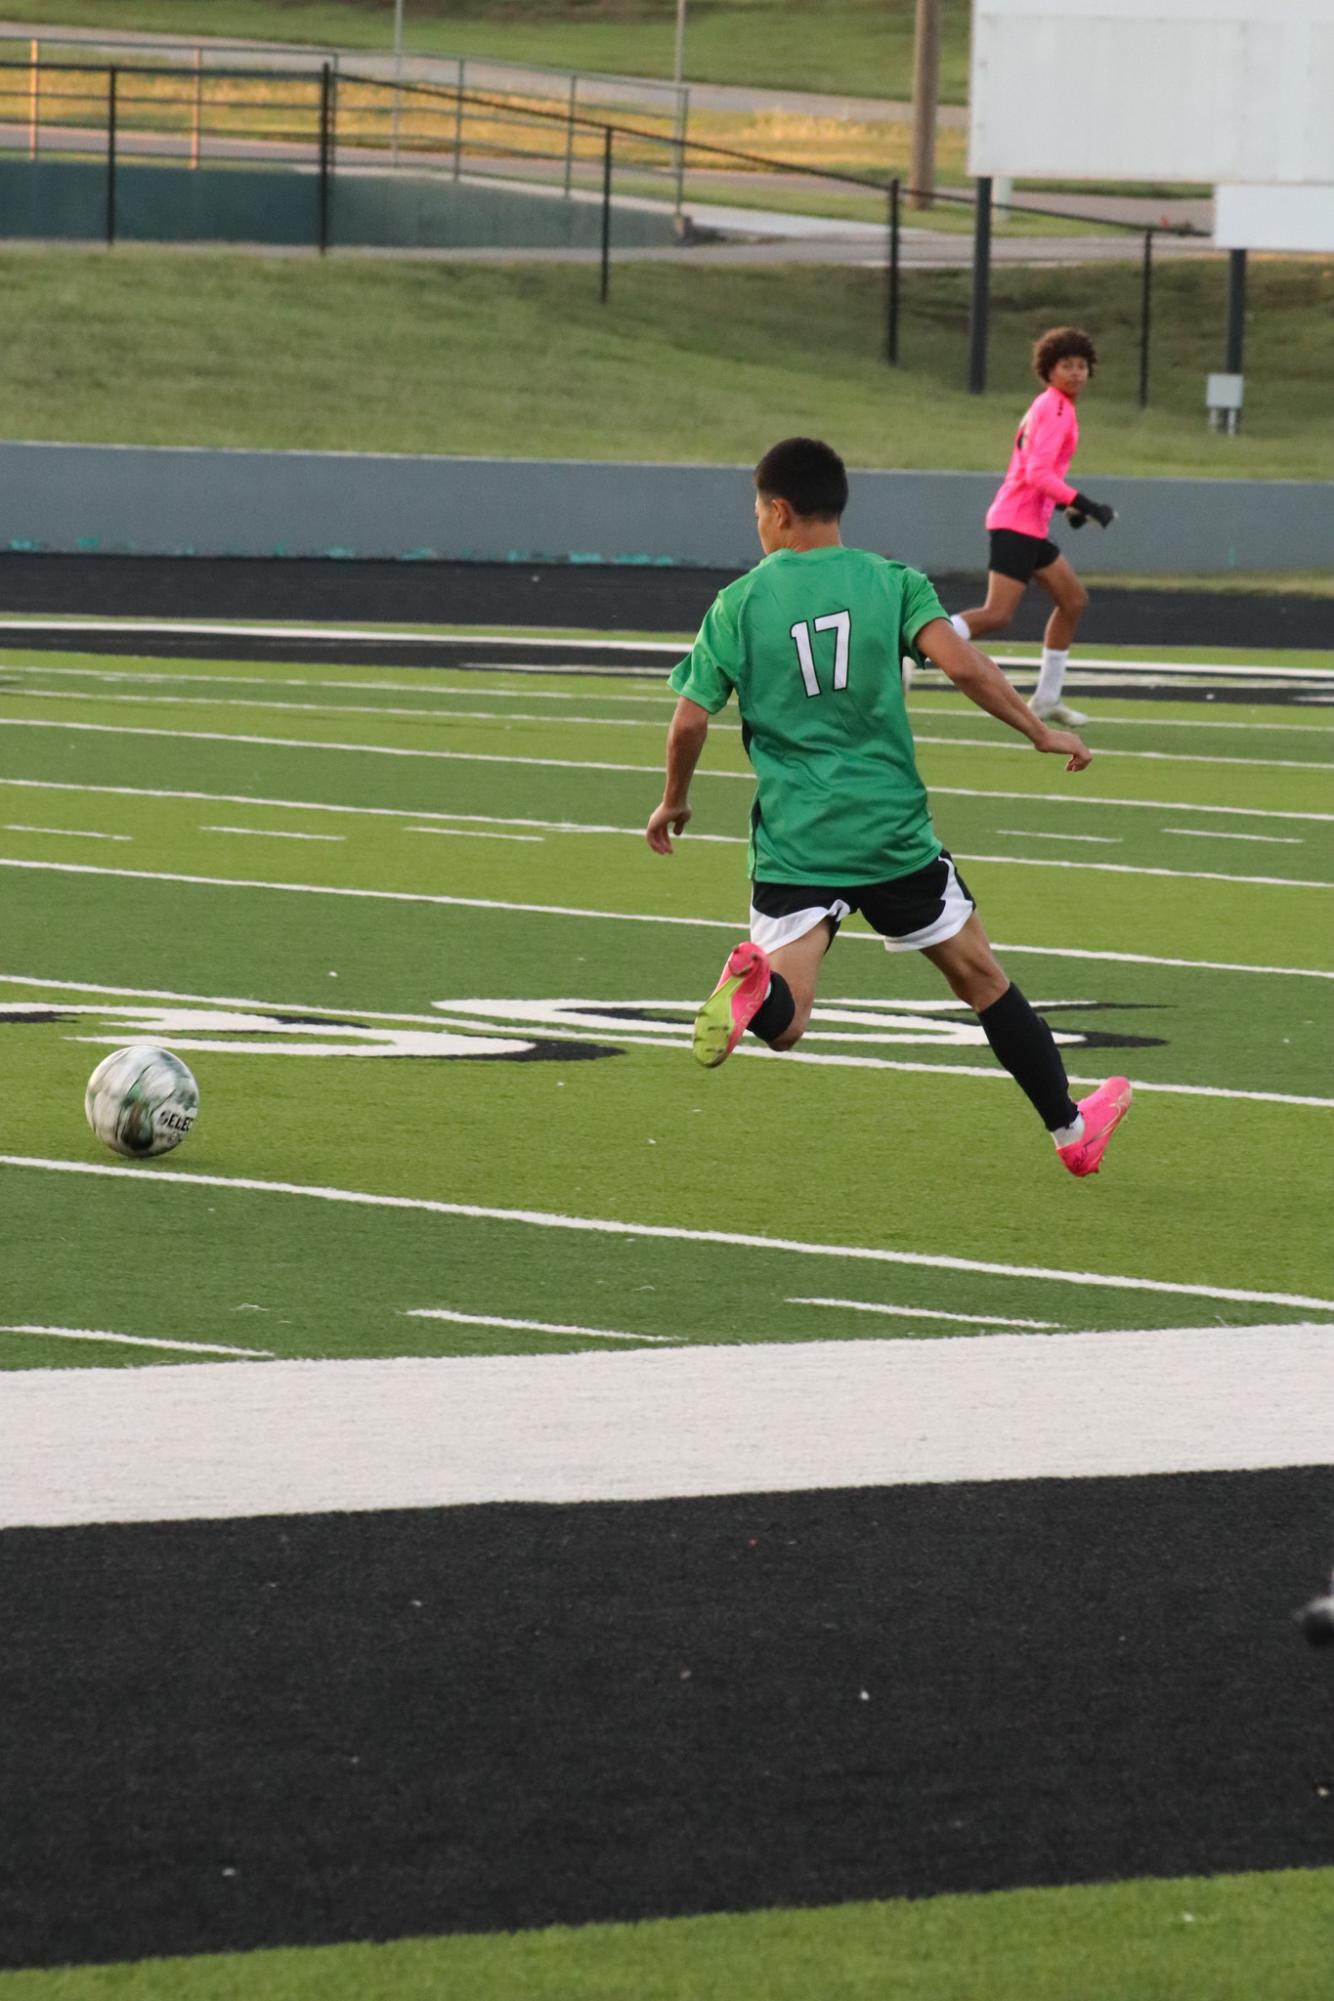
(0, 246, 1334, 478)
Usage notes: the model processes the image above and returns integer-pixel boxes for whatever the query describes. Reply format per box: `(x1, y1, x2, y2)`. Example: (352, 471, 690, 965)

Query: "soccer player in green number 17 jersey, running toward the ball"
(646, 438, 1130, 1175)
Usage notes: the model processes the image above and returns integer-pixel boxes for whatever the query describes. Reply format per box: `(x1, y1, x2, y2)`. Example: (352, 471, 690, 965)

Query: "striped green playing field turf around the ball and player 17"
(0, 650, 1334, 1367)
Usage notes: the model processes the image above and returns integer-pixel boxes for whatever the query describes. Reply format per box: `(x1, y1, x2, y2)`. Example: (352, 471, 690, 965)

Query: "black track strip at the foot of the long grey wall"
(0, 556, 1334, 650)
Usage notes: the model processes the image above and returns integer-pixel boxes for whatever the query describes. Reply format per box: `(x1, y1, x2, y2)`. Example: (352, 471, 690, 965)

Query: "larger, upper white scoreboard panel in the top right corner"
(968, 0, 1334, 184)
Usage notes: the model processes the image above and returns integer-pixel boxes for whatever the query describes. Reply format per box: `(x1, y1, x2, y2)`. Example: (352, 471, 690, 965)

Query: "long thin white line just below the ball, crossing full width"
(0, 1153, 1334, 1313)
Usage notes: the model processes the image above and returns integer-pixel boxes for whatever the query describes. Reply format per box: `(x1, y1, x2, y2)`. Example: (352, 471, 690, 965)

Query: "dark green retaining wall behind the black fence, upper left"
(0, 160, 672, 250)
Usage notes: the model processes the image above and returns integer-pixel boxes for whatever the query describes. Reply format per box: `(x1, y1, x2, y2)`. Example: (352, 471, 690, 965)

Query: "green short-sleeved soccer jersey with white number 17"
(670, 544, 948, 884)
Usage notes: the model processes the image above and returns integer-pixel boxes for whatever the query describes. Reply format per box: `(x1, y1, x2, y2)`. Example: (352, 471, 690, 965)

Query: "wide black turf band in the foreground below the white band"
(0, 1471, 1334, 1967)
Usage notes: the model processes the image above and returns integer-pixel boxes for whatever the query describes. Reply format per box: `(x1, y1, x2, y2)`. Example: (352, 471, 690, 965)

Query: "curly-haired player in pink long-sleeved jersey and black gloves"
(950, 326, 1114, 728)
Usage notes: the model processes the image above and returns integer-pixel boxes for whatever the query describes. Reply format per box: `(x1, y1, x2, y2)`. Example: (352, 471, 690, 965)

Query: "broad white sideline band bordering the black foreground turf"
(0, 1323, 1334, 1527)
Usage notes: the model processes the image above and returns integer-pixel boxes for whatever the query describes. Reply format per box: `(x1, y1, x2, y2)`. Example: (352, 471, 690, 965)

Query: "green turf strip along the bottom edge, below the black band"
(0, 1869, 1334, 2001)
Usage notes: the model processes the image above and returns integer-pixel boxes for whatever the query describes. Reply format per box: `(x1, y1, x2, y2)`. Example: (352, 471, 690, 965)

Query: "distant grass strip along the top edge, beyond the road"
(5, 0, 968, 104)
